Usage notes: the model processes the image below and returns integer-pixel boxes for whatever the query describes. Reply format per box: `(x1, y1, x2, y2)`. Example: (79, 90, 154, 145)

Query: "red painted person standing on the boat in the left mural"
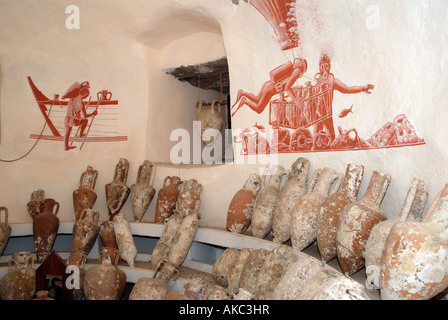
(62, 82, 97, 151)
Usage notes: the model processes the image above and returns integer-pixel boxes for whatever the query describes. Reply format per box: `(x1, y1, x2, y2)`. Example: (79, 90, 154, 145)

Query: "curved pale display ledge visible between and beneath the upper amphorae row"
(0, 222, 379, 300)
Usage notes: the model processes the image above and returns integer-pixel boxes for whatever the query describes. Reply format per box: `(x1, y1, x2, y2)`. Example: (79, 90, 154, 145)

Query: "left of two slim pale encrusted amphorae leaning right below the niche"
(151, 213, 183, 269)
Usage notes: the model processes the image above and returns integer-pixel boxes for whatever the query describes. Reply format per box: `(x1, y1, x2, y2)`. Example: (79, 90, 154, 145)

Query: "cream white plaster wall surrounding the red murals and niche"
(0, 0, 448, 227)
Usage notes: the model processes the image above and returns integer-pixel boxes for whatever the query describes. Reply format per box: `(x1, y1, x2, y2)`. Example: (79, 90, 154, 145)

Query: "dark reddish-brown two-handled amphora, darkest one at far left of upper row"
(33, 198, 59, 263)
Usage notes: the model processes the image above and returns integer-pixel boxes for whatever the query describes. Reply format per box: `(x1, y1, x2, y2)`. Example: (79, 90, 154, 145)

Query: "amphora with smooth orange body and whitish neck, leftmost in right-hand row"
(226, 174, 261, 234)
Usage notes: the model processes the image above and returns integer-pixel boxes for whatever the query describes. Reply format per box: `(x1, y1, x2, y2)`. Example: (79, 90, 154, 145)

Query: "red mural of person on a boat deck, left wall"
(28, 77, 127, 151)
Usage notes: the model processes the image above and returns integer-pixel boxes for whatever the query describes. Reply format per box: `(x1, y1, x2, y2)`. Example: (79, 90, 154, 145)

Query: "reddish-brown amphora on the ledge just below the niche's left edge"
(154, 176, 182, 224)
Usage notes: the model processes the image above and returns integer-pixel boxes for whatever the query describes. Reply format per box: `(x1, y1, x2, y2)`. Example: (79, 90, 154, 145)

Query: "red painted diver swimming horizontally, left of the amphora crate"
(232, 58, 307, 116)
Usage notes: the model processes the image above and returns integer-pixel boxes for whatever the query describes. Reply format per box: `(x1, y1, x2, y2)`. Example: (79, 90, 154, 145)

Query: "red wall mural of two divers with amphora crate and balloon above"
(232, 0, 425, 155)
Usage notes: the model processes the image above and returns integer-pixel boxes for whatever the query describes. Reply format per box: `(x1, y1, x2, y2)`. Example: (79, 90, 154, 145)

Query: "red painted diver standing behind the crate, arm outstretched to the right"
(314, 54, 374, 141)
